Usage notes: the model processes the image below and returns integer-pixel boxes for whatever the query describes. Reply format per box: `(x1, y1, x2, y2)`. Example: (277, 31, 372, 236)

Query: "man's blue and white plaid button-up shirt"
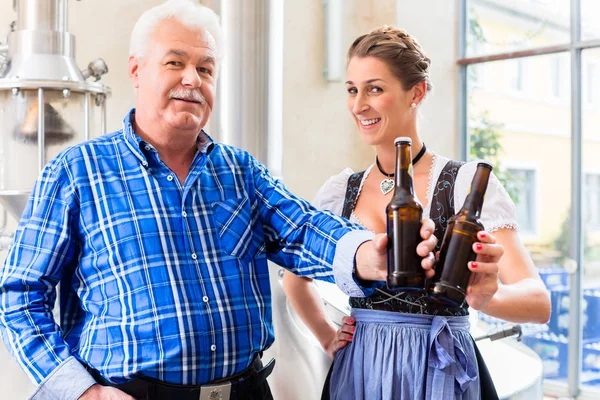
(0, 110, 371, 398)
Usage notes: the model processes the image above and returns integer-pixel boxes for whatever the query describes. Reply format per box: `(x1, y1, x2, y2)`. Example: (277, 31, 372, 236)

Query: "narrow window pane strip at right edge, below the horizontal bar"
(581, 49, 600, 392)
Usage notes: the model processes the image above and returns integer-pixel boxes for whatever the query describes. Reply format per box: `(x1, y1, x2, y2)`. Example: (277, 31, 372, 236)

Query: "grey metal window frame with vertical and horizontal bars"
(457, 0, 600, 399)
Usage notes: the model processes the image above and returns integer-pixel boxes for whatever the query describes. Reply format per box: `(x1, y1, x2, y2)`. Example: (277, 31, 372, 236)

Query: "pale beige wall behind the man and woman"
(0, 0, 458, 400)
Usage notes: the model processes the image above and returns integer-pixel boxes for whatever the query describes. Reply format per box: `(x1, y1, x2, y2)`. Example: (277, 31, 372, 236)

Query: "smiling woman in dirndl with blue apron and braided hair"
(284, 27, 550, 399)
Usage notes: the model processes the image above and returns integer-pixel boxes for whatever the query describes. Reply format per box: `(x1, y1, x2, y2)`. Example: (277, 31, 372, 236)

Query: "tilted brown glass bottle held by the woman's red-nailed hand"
(428, 162, 492, 307)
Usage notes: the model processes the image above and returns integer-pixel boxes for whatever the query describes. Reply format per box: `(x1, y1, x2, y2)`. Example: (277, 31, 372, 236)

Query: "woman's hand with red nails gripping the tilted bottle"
(466, 231, 504, 310)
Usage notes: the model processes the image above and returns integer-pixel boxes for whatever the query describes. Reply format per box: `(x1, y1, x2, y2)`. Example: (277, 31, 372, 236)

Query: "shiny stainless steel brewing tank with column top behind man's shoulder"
(0, 0, 110, 219)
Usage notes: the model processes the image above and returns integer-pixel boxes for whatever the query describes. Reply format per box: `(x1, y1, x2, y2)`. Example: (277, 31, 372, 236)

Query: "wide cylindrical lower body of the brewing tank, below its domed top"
(0, 84, 106, 219)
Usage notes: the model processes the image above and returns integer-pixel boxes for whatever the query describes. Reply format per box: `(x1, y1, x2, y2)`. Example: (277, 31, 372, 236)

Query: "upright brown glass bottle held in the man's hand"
(386, 137, 425, 291)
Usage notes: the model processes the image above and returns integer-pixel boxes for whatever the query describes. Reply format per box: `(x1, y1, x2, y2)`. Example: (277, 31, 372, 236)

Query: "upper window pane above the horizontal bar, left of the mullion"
(467, 0, 568, 57)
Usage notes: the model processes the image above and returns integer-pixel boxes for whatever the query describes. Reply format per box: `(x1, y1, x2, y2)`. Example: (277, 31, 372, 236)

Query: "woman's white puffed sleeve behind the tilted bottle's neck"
(454, 161, 517, 232)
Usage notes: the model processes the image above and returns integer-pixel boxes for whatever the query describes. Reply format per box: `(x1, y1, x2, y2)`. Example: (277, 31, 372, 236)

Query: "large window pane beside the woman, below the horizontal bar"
(468, 53, 572, 382)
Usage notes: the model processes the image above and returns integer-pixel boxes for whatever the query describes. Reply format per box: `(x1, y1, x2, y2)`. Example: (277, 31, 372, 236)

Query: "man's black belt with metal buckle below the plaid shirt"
(88, 354, 275, 400)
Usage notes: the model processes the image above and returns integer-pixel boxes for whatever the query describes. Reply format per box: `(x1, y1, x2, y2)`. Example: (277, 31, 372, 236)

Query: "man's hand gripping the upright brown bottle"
(356, 219, 437, 281)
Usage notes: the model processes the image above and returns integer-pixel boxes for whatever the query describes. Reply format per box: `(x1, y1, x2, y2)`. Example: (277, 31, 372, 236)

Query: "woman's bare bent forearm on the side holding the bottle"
(481, 278, 551, 324)
